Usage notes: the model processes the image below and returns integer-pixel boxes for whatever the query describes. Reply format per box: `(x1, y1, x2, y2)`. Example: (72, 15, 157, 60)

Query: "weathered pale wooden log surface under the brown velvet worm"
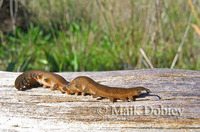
(0, 69, 200, 131)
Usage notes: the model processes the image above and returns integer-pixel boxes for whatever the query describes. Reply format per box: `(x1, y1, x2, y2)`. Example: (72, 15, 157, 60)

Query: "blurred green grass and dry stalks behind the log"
(0, 0, 200, 72)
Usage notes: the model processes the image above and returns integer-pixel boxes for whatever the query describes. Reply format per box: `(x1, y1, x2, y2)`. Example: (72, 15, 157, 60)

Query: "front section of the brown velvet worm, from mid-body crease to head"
(63, 76, 151, 102)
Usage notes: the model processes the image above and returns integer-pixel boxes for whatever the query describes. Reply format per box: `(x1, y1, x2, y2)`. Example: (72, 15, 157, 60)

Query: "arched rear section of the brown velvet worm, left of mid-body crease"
(15, 70, 69, 93)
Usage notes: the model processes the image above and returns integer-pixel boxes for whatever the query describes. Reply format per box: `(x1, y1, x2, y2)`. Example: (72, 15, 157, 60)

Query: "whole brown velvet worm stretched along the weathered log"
(15, 70, 151, 102)
